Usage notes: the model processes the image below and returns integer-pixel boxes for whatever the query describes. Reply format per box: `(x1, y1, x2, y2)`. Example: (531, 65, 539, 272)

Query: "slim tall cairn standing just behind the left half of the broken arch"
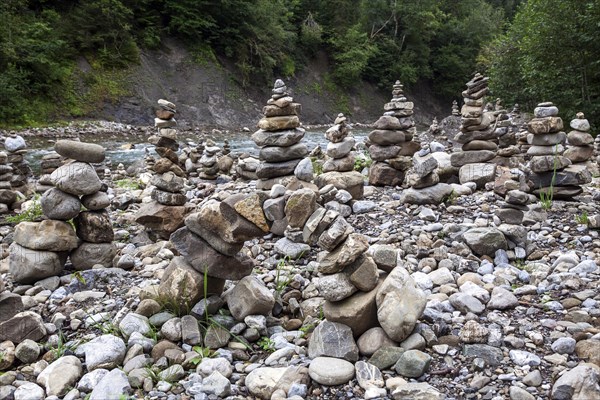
(149, 99, 187, 206)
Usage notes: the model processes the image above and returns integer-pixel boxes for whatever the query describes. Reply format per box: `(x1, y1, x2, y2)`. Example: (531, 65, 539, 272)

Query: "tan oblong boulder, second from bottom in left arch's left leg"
(14, 219, 77, 252)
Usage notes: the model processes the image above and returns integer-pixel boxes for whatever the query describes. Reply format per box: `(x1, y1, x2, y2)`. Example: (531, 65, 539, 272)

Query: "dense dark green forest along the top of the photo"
(0, 0, 600, 126)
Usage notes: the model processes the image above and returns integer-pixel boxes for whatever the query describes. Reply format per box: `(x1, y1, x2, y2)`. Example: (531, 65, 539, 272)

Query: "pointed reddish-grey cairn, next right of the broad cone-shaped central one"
(369, 81, 420, 186)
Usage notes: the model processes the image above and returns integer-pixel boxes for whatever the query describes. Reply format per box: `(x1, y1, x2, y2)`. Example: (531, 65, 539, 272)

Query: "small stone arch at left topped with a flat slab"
(9, 140, 116, 284)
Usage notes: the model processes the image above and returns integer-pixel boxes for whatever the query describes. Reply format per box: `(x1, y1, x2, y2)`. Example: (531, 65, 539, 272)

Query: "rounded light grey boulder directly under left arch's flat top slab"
(50, 161, 102, 196)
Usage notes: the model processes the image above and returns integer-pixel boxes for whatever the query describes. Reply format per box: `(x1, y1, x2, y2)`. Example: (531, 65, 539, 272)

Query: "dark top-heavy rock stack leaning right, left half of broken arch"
(159, 193, 274, 310)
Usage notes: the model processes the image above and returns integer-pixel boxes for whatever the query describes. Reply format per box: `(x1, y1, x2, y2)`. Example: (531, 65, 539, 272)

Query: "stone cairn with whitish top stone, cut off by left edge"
(0, 133, 31, 214)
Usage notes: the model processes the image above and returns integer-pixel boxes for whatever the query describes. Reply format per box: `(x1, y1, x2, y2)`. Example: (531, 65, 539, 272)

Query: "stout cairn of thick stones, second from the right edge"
(527, 102, 592, 200)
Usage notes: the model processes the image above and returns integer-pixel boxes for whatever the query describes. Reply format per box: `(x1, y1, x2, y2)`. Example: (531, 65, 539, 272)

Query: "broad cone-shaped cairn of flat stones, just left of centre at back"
(252, 79, 308, 190)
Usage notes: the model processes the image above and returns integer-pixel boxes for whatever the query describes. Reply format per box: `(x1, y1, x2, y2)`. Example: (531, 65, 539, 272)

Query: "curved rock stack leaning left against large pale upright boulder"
(303, 208, 427, 346)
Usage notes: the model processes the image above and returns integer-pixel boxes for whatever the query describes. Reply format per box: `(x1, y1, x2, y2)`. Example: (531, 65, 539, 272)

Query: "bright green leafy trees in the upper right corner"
(483, 0, 600, 121)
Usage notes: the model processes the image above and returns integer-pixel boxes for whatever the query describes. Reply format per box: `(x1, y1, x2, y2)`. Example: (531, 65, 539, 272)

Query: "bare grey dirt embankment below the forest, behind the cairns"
(92, 39, 450, 130)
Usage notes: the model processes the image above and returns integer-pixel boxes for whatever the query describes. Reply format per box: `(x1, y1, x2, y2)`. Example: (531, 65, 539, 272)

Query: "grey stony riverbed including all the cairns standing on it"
(0, 74, 600, 400)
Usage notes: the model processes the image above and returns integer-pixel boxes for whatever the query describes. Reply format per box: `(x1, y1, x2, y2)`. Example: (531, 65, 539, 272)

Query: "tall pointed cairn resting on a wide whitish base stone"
(450, 73, 498, 188)
